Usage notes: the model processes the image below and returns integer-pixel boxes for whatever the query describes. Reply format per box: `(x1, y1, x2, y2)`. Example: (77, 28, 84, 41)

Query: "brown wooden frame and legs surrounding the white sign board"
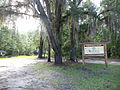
(80, 42, 108, 67)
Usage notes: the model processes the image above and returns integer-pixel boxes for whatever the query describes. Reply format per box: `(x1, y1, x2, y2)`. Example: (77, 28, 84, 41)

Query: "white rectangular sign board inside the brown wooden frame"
(84, 46, 104, 54)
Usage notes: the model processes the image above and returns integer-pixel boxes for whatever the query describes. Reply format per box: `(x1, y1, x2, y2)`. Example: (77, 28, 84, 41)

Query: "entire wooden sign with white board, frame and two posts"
(81, 42, 108, 67)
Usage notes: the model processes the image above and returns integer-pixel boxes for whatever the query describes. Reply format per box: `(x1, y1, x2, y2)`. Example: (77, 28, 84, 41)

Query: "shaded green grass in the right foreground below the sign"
(33, 63, 120, 90)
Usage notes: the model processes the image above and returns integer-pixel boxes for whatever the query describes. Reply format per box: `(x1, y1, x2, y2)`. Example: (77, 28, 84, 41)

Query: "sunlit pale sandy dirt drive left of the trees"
(0, 58, 53, 90)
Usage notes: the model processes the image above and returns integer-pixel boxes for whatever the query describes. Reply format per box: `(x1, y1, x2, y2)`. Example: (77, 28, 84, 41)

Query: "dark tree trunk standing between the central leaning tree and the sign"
(70, 21, 76, 62)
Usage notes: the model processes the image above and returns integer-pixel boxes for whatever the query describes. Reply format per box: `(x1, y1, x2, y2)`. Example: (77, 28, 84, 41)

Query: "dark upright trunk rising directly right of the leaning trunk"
(55, 0, 63, 64)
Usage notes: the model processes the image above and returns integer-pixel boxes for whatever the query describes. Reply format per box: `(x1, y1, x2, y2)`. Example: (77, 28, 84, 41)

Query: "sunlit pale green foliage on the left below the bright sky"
(0, 27, 39, 55)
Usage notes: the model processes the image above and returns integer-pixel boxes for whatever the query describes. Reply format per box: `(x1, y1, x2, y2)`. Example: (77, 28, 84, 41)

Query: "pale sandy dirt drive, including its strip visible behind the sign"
(0, 58, 120, 90)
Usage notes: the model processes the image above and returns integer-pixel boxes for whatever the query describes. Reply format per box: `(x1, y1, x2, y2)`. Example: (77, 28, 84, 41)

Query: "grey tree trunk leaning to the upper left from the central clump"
(36, 0, 62, 65)
